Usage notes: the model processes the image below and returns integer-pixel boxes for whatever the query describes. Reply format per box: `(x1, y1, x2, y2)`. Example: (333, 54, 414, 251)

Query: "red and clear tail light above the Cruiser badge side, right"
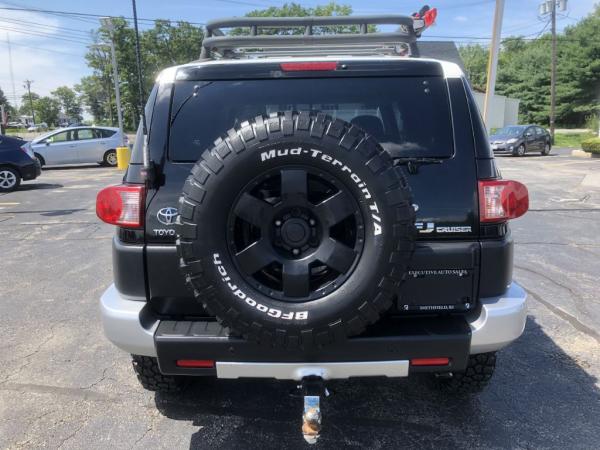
(479, 180, 529, 222)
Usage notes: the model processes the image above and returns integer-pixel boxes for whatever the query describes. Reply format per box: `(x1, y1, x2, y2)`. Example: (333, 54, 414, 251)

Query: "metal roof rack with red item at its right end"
(200, 6, 437, 59)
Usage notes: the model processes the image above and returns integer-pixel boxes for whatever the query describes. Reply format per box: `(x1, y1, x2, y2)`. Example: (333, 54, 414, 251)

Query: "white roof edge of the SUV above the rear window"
(156, 55, 464, 84)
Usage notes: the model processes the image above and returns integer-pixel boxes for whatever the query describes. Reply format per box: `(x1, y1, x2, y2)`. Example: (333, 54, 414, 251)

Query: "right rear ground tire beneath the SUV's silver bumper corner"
(440, 352, 496, 394)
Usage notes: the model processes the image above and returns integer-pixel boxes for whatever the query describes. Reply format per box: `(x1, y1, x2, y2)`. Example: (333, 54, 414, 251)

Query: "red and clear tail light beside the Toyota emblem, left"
(96, 184, 146, 228)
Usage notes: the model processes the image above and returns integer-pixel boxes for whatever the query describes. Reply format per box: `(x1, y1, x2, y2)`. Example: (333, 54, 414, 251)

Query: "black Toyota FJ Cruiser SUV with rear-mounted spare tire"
(97, 15, 528, 442)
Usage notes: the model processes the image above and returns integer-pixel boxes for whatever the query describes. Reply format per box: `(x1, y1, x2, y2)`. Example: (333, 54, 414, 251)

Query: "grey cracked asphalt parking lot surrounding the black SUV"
(0, 151, 600, 449)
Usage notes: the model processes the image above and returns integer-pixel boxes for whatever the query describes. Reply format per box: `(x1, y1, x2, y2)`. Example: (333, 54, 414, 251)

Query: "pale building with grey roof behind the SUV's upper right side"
(417, 41, 520, 128)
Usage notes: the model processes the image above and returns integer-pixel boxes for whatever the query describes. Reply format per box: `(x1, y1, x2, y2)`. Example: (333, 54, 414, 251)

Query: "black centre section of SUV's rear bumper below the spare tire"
(154, 316, 471, 379)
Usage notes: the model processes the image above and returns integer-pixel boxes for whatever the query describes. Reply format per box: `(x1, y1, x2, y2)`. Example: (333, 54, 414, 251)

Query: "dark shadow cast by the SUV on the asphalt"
(155, 318, 600, 449)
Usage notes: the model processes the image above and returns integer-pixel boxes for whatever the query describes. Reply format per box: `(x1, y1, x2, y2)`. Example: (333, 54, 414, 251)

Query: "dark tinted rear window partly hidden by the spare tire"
(169, 77, 454, 161)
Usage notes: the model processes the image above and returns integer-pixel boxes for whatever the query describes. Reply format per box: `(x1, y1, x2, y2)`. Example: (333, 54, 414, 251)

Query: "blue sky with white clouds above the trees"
(0, 0, 600, 109)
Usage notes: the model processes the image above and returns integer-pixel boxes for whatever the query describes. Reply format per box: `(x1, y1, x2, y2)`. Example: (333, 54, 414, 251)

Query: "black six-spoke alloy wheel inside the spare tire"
(228, 167, 364, 302)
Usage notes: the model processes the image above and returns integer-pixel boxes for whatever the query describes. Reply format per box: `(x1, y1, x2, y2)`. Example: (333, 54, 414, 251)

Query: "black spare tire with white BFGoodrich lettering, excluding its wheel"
(177, 111, 416, 349)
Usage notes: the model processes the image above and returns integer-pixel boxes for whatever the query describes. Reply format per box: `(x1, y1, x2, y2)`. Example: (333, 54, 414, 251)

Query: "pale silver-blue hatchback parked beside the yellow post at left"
(26, 127, 127, 166)
